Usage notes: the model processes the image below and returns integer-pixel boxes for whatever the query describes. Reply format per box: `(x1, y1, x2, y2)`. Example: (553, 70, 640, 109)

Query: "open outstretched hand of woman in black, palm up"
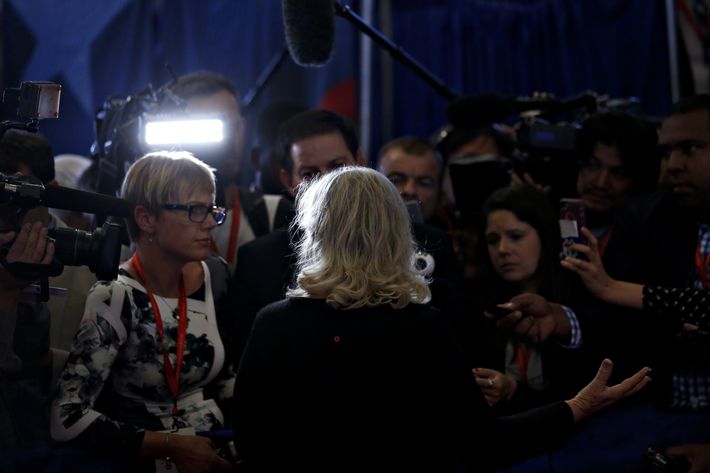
(566, 358, 651, 422)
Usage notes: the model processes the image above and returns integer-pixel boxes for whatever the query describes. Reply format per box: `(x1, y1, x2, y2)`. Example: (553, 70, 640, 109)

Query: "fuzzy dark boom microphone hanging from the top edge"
(281, 0, 335, 67)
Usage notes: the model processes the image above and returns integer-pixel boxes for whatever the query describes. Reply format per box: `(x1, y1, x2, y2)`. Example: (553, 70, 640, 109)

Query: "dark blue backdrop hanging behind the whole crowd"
(2, 0, 670, 183)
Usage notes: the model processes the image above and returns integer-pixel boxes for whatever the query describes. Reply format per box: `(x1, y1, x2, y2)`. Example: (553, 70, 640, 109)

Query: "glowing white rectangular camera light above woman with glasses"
(144, 118, 224, 145)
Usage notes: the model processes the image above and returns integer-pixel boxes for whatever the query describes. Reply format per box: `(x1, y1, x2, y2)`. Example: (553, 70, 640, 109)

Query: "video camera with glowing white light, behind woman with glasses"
(91, 80, 230, 199)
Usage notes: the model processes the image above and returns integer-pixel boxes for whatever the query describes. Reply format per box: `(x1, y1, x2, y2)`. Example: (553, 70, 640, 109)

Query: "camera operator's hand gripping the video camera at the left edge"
(0, 222, 54, 306)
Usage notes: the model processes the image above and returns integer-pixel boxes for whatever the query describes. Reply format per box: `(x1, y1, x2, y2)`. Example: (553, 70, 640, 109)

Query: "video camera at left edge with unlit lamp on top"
(0, 82, 133, 300)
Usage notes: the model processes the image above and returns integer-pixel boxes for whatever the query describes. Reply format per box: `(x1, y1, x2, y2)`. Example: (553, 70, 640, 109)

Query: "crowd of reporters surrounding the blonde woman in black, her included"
(0, 68, 710, 473)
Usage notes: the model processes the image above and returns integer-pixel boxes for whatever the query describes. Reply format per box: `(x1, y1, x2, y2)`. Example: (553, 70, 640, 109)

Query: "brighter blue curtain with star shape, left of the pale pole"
(2, 0, 357, 180)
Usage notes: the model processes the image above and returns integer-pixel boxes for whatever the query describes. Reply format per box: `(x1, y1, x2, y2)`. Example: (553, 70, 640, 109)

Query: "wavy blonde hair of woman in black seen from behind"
(287, 166, 431, 309)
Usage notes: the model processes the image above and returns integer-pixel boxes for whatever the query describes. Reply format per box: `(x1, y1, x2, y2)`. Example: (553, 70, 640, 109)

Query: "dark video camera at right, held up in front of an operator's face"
(434, 92, 638, 215)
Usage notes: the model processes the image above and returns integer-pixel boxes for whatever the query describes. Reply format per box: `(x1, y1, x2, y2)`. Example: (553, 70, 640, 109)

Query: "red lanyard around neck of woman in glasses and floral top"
(131, 252, 187, 417)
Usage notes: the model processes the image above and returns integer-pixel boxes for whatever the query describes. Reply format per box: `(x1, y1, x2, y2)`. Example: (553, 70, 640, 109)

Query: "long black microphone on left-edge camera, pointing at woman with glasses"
(41, 186, 135, 217)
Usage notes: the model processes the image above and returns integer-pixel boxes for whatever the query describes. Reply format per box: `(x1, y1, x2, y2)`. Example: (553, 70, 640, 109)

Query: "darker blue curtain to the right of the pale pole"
(383, 0, 671, 153)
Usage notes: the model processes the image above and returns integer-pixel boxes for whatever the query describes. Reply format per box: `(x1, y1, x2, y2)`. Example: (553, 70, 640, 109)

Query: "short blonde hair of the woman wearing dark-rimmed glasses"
(121, 151, 215, 242)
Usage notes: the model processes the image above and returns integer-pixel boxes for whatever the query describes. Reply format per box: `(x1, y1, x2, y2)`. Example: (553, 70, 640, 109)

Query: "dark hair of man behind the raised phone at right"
(578, 111, 660, 193)
